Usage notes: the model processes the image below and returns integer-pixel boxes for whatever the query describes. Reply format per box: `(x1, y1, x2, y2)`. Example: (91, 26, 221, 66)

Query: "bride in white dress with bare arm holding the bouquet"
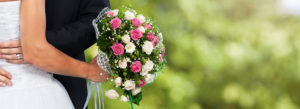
(0, 0, 109, 109)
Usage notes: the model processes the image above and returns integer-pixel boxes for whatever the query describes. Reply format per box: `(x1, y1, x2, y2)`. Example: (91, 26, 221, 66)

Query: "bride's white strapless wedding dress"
(0, 1, 74, 109)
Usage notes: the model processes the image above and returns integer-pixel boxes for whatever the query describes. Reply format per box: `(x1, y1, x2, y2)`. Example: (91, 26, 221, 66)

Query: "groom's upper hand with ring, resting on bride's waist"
(0, 40, 24, 64)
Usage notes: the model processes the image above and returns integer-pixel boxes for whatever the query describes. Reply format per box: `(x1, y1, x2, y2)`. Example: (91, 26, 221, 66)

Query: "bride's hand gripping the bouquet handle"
(87, 57, 110, 82)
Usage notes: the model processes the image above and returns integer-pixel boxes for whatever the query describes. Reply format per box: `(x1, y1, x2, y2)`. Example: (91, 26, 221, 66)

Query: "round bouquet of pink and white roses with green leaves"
(96, 8, 166, 105)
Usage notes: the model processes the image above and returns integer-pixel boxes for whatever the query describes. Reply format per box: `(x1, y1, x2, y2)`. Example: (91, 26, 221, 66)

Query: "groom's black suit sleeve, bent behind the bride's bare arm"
(46, 0, 110, 55)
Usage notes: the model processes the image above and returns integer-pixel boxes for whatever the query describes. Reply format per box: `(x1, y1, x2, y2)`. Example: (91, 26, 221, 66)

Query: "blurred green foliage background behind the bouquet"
(86, 0, 300, 109)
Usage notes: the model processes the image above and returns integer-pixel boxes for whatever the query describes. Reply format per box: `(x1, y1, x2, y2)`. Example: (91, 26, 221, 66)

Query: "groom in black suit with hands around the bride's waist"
(0, 0, 110, 109)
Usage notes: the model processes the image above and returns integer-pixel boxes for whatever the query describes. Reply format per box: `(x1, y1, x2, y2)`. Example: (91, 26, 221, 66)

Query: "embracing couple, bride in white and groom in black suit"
(0, 0, 109, 109)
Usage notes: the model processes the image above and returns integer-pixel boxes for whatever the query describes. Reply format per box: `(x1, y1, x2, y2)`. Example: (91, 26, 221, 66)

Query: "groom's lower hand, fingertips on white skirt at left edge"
(0, 68, 12, 87)
